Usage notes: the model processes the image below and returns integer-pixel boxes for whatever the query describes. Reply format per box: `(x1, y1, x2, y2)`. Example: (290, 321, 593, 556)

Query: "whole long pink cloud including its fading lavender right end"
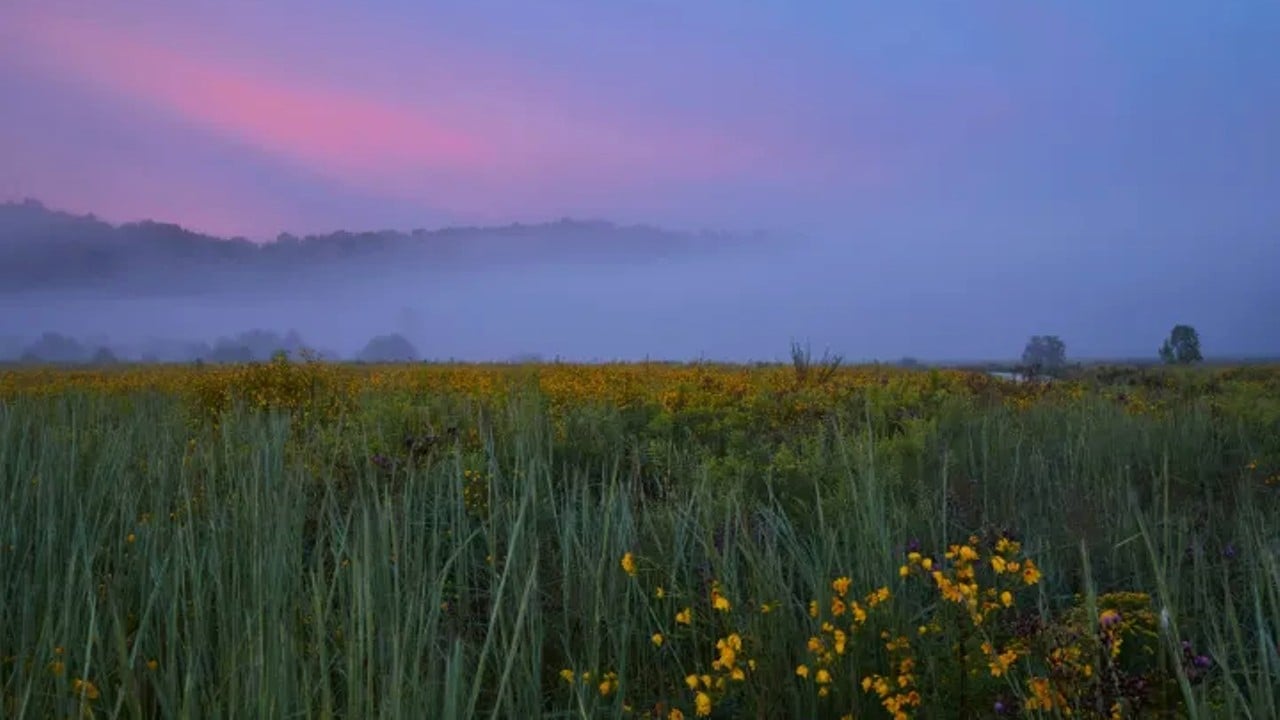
(10, 9, 803, 219)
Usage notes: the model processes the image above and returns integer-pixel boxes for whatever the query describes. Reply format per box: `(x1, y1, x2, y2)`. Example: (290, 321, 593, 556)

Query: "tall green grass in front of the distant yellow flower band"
(0, 381, 1280, 719)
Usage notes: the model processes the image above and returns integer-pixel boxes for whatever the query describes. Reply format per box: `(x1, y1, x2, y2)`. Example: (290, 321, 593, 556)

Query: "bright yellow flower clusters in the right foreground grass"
(599, 537, 1172, 720)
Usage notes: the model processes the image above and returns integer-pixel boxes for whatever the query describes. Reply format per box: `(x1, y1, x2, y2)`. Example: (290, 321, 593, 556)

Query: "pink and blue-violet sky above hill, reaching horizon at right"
(0, 0, 1280, 355)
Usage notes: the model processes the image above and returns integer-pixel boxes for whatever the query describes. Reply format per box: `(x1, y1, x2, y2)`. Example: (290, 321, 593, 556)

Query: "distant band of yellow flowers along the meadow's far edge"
(0, 356, 1146, 423)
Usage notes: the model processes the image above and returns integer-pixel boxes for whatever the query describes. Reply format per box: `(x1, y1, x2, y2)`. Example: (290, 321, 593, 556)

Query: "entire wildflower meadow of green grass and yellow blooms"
(0, 357, 1280, 720)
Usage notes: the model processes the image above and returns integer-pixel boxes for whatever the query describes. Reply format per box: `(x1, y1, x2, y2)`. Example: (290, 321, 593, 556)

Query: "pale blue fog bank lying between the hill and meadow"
(0, 224, 1280, 361)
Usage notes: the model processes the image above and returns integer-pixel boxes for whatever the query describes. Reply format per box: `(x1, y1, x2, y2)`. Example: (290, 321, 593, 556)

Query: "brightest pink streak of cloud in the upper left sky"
(22, 18, 492, 177)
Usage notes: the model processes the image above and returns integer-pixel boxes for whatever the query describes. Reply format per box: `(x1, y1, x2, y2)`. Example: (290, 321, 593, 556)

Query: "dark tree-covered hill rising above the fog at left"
(0, 200, 728, 296)
